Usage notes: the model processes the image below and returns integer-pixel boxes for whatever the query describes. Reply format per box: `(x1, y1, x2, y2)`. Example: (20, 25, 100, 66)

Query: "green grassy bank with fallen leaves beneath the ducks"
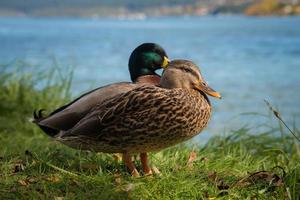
(0, 65, 300, 200)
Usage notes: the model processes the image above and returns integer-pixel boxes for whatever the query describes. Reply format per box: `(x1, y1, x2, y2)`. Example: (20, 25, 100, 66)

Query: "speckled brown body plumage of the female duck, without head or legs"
(56, 86, 211, 153)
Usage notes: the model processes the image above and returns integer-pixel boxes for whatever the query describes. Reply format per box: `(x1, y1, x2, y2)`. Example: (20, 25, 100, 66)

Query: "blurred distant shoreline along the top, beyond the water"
(0, 0, 300, 19)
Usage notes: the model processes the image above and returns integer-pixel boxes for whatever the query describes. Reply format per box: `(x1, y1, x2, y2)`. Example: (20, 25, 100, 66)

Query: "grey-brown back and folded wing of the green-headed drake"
(34, 82, 137, 136)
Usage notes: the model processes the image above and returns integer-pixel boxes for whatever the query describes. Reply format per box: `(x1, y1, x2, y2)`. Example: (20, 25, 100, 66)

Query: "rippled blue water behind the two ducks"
(0, 16, 300, 140)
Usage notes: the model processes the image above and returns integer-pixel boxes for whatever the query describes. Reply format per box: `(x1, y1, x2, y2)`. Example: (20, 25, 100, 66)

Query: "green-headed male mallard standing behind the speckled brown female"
(33, 43, 169, 137)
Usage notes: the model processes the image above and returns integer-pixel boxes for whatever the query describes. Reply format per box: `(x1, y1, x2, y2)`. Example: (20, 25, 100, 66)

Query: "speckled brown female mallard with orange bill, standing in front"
(47, 60, 221, 175)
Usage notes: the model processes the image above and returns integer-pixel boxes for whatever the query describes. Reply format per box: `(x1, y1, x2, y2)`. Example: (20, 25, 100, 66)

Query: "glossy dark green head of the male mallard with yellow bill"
(128, 43, 170, 82)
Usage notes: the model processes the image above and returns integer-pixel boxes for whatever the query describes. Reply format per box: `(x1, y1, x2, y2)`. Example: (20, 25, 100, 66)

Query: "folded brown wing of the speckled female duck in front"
(59, 85, 177, 140)
